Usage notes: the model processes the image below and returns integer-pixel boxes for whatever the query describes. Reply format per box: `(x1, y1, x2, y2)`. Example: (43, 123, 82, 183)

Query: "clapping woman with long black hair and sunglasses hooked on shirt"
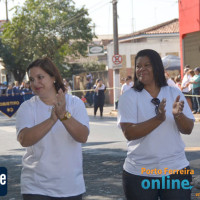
(118, 49, 194, 200)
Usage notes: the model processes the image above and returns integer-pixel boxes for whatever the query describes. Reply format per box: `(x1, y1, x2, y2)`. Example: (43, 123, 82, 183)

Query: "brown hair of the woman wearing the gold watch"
(27, 57, 66, 92)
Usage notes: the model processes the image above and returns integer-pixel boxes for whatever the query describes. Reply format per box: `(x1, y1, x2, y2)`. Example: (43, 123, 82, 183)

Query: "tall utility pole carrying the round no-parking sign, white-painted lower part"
(112, 0, 120, 109)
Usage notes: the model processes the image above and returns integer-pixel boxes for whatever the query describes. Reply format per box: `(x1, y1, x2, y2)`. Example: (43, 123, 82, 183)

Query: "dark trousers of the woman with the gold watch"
(23, 194, 82, 200)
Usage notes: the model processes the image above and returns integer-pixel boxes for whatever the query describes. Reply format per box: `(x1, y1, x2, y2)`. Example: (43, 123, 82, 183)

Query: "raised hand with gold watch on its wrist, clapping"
(54, 89, 66, 119)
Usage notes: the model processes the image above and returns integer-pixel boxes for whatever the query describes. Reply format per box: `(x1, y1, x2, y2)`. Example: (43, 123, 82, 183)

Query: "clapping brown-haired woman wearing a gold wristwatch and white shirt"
(16, 58, 89, 200)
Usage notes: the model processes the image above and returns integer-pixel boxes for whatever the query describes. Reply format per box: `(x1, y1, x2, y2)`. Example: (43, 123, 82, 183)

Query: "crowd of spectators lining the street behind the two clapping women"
(0, 65, 200, 116)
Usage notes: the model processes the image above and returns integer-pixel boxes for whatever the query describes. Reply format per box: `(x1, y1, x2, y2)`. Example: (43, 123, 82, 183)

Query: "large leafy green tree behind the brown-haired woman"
(2, 0, 93, 80)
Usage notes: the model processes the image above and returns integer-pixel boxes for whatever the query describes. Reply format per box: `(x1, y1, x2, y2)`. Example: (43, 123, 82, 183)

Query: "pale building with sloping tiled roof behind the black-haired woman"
(107, 19, 180, 102)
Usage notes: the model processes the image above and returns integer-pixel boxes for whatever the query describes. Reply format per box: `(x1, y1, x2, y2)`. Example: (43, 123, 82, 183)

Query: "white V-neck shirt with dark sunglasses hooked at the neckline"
(118, 86, 194, 177)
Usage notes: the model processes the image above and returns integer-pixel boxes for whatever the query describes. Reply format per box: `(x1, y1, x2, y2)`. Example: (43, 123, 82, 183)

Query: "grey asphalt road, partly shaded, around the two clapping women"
(0, 114, 200, 200)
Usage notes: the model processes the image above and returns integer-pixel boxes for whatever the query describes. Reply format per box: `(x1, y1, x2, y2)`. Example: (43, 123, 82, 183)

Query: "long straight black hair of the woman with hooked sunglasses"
(133, 49, 167, 92)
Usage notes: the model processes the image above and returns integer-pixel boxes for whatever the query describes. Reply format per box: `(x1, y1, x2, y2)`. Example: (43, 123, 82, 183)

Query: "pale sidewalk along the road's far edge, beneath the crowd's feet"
(87, 105, 200, 122)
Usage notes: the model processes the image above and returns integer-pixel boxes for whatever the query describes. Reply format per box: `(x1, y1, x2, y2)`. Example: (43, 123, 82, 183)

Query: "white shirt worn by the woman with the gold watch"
(16, 94, 89, 197)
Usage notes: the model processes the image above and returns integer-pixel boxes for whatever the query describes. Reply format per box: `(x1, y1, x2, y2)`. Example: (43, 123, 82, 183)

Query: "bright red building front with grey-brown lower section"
(179, 0, 200, 75)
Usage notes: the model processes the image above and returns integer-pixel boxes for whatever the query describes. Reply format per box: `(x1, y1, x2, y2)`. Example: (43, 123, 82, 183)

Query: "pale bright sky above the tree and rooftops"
(0, 0, 178, 35)
